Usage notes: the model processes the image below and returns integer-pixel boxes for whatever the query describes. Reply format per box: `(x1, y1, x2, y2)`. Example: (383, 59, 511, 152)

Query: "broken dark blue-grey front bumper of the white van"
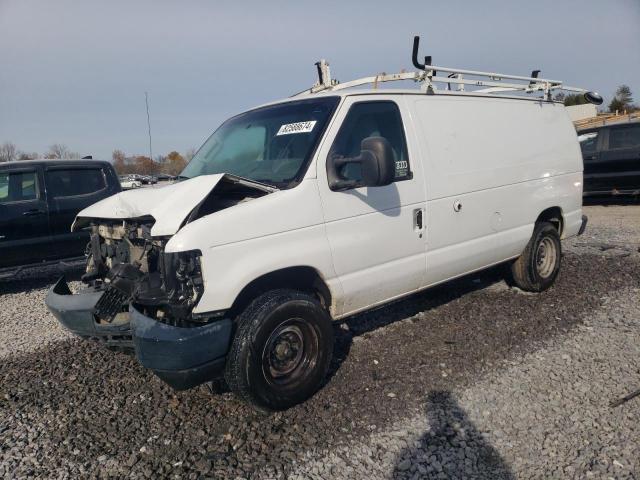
(45, 277, 232, 390)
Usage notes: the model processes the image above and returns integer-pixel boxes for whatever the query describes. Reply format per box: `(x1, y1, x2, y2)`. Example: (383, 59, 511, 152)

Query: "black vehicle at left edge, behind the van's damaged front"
(0, 159, 120, 268)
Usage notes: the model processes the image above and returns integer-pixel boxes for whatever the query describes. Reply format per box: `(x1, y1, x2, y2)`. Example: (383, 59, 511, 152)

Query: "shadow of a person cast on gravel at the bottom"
(393, 391, 515, 480)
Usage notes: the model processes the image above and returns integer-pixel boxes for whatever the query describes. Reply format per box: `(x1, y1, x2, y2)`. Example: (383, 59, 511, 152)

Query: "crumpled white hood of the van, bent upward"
(71, 173, 276, 237)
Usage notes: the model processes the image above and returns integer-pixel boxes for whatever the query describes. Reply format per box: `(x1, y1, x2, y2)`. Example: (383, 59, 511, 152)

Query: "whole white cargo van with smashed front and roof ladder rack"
(46, 42, 601, 410)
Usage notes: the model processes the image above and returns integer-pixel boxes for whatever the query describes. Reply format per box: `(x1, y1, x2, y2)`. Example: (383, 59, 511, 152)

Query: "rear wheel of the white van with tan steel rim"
(511, 222, 562, 292)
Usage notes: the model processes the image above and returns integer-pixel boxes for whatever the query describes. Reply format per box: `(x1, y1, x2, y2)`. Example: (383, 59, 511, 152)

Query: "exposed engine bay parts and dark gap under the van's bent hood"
(82, 181, 268, 327)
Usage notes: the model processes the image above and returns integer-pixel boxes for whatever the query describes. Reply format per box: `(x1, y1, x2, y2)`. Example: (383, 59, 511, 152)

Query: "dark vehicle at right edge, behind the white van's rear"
(578, 122, 640, 195)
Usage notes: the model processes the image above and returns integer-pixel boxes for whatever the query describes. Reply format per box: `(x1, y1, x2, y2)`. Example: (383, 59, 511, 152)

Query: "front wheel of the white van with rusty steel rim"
(225, 290, 333, 411)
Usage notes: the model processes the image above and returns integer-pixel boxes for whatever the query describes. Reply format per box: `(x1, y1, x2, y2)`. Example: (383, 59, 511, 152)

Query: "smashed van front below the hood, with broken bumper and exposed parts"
(46, 218, 232, 390)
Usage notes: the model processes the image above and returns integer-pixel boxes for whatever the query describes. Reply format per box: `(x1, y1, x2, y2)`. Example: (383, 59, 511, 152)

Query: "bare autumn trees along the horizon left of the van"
(0, 142, 195, 175)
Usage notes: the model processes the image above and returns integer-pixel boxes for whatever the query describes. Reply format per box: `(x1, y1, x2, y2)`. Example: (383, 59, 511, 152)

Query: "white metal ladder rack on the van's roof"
(294, 36, 602, 105)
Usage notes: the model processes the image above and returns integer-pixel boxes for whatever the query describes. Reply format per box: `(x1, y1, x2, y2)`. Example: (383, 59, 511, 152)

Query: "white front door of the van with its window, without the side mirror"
(317, 95, 426, 315)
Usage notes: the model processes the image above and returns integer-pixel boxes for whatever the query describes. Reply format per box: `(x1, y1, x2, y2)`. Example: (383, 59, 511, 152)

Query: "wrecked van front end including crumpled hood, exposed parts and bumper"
(46, 174, 277, 389)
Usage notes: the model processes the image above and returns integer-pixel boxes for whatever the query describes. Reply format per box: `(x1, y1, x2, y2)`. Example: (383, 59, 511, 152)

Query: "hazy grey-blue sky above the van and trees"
(0, 0, 640, 159)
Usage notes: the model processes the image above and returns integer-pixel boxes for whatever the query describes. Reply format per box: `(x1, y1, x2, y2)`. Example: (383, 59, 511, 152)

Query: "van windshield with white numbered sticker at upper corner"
(181, 97, 339, 188)
